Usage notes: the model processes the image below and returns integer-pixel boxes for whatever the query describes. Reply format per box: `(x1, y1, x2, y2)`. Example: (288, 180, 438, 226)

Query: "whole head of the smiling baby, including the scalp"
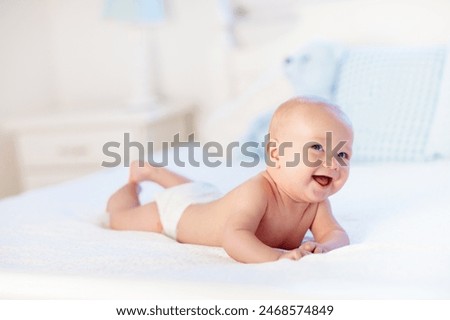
(267, 98, 353, 202)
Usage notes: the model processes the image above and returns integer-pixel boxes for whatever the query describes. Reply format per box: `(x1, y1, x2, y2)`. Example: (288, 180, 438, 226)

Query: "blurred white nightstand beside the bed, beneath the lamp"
(4, 107, 194, 191)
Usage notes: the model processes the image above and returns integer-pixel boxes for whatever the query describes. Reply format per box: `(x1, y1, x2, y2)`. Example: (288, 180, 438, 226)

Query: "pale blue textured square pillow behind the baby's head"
(334, 46, 446, 161)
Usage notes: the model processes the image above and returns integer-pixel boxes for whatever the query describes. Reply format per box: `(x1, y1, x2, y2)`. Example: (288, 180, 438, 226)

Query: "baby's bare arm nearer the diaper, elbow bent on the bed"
(223, 181, 283, 263)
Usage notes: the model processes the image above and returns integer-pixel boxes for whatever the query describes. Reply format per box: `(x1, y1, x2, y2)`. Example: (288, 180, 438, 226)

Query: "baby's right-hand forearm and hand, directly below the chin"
(300, 200, 350, 253)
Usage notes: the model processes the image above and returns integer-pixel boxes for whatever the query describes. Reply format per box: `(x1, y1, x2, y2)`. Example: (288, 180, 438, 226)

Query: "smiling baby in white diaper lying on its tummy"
(107, 98, 353, 263)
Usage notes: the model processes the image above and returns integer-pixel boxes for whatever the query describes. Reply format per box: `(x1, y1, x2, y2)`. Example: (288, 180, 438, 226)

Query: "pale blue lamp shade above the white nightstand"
(103, 0, 165, 24)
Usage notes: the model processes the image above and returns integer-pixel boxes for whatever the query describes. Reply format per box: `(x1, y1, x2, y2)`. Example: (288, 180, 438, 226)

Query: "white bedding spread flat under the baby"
(0, 149, 450, 299)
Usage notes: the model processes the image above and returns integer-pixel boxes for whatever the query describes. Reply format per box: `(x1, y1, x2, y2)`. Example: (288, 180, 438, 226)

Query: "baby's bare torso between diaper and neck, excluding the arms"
(177, 172, 317, 249)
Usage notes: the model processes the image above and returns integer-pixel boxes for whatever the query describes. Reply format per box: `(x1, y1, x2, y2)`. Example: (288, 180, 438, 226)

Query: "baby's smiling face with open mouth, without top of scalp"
(272, 107, 353, 202)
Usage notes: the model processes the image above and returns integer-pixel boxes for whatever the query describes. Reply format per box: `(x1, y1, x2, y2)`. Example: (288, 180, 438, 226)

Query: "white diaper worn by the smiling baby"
(155, 182, 222, 239)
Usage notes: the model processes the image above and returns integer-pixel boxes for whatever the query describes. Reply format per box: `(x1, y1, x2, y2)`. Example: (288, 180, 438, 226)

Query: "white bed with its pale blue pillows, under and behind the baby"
(0, 1, 450, 299)
